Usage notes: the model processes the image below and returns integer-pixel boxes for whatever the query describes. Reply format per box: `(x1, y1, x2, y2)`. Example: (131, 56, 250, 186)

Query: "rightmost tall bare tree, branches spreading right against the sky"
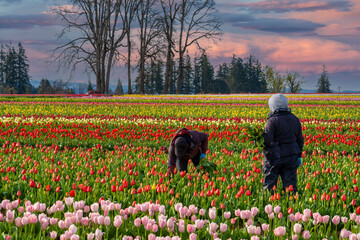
(176, 0, 221, 94)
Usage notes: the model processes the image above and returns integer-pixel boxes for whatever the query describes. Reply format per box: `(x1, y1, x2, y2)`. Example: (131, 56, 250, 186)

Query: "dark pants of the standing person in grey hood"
(263, 155, 298, 192)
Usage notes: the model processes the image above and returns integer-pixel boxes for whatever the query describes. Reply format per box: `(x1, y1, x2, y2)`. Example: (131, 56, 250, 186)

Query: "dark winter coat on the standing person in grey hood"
(264, 111, 304, 161)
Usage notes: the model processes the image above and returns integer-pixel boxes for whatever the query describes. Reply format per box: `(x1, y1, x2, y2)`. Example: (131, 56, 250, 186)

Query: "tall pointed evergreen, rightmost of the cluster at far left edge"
(16, 43, 31, 93)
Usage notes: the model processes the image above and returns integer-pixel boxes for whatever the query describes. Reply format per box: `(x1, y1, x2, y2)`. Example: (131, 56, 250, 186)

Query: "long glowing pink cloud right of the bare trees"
(201, 35, 360, 75)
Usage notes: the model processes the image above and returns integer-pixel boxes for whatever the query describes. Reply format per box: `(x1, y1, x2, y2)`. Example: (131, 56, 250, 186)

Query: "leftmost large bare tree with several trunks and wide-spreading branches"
(52, 0, 131, 93)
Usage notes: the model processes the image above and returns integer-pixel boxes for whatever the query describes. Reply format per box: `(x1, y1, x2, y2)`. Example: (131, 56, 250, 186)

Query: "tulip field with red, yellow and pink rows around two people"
(0, 94, 360, 240)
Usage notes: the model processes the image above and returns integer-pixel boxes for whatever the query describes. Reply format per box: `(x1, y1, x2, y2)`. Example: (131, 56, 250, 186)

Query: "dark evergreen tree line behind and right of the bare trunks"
(128, 52, 304, 94)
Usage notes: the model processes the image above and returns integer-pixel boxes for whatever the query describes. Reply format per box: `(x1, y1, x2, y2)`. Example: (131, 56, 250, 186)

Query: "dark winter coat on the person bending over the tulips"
(167, 130, 208, 168)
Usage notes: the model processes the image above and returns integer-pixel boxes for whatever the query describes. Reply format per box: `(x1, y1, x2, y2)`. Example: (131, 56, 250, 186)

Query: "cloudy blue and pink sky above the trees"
(0, 0, 360, 91)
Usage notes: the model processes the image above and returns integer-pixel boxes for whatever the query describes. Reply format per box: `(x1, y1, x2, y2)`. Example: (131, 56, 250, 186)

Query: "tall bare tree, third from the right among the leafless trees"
(137, 0, 163, 94)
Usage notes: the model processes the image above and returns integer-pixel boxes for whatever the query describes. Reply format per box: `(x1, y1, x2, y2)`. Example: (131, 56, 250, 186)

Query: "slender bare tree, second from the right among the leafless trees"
(160, 0, 180, 94)
